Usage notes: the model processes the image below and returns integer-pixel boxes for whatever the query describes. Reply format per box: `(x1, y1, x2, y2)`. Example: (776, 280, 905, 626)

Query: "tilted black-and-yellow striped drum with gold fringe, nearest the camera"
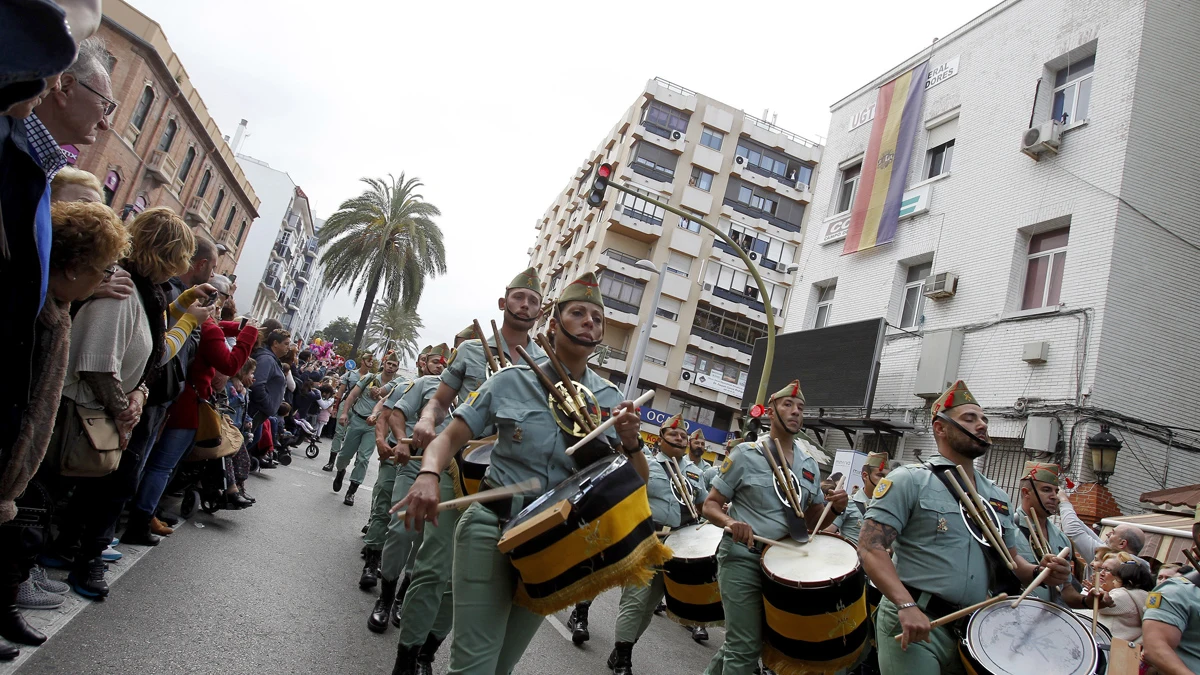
(499, 456, 671, 615)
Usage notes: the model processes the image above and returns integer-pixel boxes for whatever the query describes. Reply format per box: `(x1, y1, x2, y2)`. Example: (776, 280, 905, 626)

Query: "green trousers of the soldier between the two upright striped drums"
(704, 534, 762, 675)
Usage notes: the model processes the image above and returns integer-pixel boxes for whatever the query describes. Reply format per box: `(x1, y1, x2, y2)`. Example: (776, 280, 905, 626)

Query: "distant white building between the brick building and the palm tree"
(234, 155, 325, 338)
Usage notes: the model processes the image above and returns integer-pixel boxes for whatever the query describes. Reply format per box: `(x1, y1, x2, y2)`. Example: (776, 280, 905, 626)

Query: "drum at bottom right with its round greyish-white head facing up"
(959, 597, 1099, 675)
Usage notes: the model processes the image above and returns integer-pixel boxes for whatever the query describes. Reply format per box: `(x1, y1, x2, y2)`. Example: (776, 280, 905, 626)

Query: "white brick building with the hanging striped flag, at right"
(786, 0, 1200, 514)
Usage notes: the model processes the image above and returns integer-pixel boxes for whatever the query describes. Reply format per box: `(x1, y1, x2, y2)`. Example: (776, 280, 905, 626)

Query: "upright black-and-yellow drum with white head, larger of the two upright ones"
(761, 532, 870, 673)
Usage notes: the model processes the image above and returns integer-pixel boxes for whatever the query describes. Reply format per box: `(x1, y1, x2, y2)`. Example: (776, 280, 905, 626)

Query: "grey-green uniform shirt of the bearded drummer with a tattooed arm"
(865, 455, 1020, 605)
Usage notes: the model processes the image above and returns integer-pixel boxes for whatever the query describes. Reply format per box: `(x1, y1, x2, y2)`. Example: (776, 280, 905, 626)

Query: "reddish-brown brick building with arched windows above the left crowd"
(66, 0, 259, 274)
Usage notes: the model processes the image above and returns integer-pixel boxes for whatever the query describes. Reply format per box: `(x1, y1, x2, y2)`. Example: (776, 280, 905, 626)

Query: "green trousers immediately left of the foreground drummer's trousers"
(400, 471, 462, 647)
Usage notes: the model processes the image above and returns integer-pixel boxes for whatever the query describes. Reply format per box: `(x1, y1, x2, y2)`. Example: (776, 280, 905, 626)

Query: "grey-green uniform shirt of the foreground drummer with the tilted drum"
(454, 354, 623, 491)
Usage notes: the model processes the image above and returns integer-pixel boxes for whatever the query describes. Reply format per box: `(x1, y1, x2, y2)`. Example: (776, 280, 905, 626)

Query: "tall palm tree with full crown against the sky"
(318, 173, 446, 354)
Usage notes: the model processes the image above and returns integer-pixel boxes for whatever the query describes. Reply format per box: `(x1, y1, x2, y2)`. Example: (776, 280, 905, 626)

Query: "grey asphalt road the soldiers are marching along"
(11, 440, 724, 675)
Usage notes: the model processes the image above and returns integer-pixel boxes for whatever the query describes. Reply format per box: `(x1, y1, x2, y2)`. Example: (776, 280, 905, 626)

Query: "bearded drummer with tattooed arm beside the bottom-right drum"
(858, 380, 1070, 675)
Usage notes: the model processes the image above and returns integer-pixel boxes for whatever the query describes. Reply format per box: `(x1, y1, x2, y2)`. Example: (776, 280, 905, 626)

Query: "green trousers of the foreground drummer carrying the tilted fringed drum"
(448, 503, 545, 675)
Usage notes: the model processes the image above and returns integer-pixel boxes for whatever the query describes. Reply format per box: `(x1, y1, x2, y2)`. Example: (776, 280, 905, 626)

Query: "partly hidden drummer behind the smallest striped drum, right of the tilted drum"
(608, 414, 704, 675)
